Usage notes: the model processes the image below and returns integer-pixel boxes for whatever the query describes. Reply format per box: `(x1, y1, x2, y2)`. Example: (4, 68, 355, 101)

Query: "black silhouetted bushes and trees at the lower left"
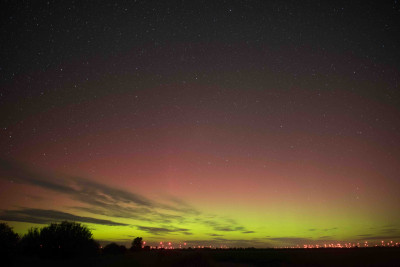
(0, 221, 142, 258)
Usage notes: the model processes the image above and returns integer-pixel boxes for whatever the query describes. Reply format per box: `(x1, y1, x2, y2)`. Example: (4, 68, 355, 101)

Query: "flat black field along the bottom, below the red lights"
(11, 248, 400, 267)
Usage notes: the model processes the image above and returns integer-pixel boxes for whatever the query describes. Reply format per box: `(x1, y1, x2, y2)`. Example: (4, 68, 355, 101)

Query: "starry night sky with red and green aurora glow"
(0, 1, 400, 247)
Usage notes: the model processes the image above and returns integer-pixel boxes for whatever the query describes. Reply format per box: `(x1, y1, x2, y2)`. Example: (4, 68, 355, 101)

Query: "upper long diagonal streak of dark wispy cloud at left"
(0, 159, 198, 223)
